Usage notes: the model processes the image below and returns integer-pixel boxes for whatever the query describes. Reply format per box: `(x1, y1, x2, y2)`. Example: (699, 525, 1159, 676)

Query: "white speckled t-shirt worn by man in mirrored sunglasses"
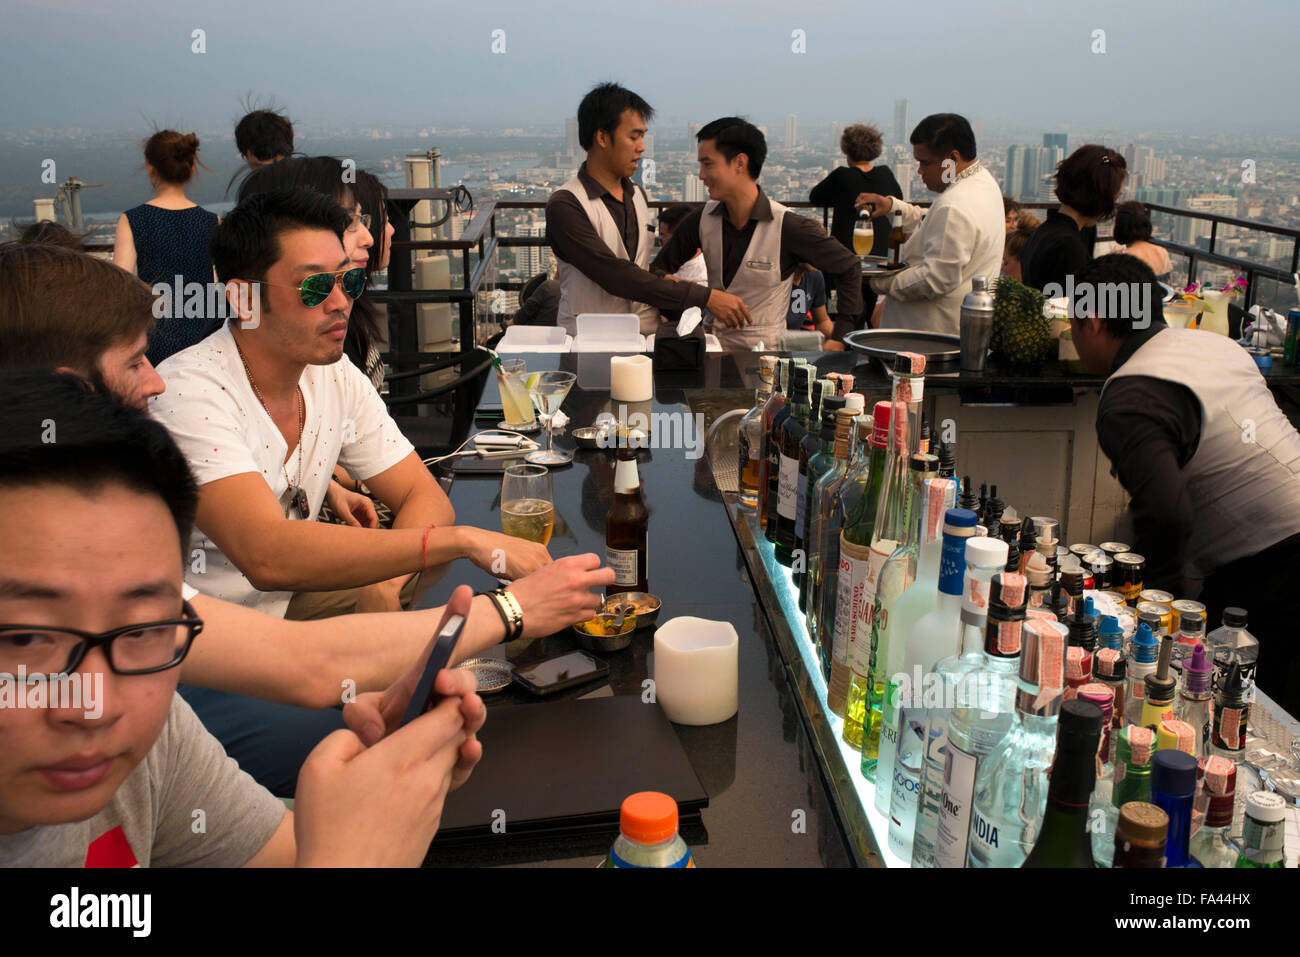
(150, 325, 413, 618)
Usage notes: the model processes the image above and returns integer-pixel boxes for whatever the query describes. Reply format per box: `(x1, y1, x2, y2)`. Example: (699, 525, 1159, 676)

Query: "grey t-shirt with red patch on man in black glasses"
(0, 694, 285, 867)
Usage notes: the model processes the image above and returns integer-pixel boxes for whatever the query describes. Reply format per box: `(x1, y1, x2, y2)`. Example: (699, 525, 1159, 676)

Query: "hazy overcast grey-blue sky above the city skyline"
(0, 0, 1300, 138)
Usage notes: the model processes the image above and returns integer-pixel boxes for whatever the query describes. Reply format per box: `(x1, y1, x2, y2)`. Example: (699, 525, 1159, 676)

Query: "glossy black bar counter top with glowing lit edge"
(421, 352, 1300, 867)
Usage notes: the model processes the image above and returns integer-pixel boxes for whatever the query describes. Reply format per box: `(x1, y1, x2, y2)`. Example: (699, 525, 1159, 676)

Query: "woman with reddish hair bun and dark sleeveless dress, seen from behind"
(113, 130, 220, 365)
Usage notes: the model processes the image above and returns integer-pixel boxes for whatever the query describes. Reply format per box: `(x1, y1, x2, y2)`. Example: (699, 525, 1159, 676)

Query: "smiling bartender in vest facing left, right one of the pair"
(650, 116, 862, 350)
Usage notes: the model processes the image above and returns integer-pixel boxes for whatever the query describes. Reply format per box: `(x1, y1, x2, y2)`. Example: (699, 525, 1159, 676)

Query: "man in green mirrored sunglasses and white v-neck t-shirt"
(151, 189, 550, 618)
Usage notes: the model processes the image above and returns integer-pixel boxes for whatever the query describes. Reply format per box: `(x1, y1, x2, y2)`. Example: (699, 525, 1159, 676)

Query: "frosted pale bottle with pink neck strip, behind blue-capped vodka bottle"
(863, 479, 957, 814)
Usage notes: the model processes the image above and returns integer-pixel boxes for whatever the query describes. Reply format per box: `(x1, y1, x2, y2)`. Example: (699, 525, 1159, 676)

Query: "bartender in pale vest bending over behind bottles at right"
(1070, 254, 1300, 714)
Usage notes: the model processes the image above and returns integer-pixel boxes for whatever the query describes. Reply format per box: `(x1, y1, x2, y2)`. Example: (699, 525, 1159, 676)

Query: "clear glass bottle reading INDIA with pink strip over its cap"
(966, 619, 1065, 867)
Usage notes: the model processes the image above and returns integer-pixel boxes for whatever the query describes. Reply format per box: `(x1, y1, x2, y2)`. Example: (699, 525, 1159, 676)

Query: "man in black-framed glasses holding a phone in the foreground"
(0, 372, 485, 867)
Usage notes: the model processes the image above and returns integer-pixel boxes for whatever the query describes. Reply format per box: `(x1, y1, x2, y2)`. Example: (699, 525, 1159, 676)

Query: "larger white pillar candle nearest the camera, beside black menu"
(654, 616, 740, 726)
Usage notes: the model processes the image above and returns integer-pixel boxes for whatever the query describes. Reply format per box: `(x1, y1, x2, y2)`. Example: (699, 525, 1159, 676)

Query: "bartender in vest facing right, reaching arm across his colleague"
(546, 83, 749, 335)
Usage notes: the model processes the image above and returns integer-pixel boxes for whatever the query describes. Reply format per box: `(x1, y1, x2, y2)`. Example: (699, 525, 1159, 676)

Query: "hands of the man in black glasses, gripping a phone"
(294, 585, 488, 867)
